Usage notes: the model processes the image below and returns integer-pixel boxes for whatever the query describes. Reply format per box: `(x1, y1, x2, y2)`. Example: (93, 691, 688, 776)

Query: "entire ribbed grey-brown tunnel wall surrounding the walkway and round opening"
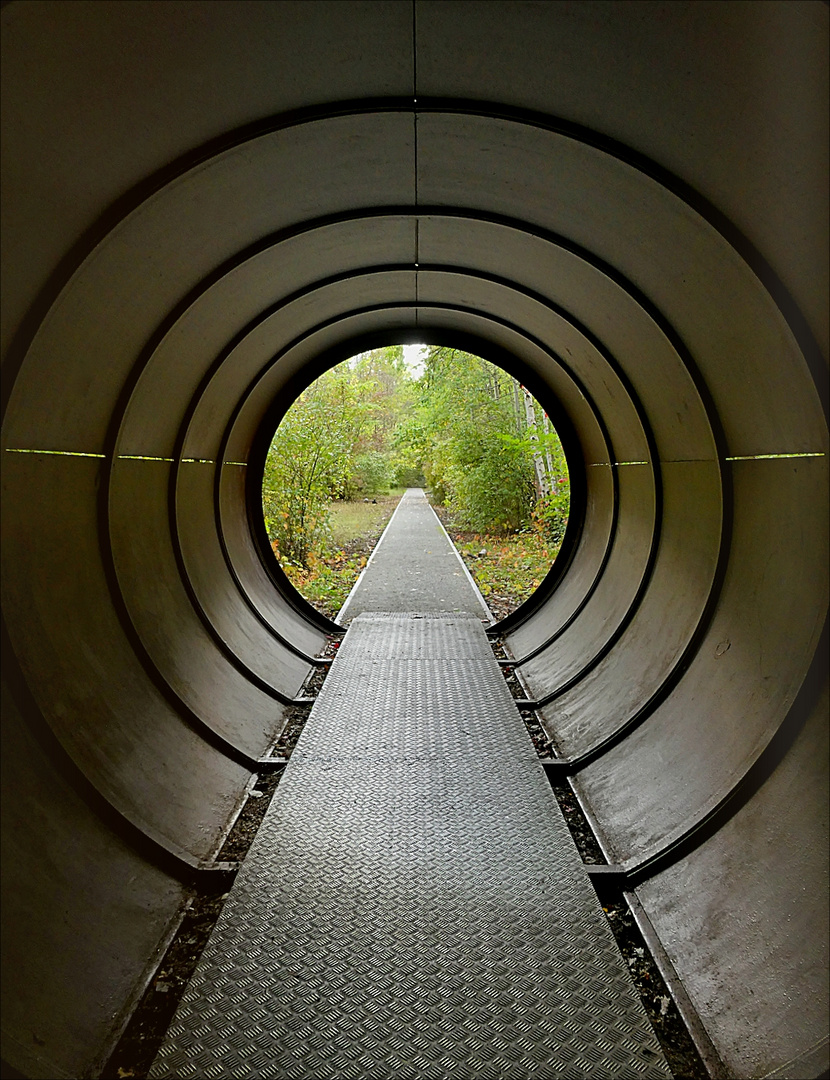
(2, 0, 829, 1078)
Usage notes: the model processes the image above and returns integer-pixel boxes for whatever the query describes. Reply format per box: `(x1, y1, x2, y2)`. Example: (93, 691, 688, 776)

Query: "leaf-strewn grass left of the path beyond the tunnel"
(282, 488, 404, 619)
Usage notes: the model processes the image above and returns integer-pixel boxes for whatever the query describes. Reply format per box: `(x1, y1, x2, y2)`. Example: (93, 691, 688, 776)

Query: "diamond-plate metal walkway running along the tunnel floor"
(150, 613, 671, 1080)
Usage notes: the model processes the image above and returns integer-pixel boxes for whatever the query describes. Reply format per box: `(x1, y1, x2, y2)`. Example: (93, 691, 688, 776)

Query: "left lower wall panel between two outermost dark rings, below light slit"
(3, 454, 249, 859)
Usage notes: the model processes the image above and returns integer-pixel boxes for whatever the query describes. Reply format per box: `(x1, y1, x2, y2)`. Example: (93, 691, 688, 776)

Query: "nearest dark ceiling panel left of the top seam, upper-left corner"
(2, 0, 412, 352)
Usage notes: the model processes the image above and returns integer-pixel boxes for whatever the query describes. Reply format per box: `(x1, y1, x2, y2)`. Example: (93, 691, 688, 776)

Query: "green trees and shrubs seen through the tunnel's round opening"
(262, 346, 570, 604)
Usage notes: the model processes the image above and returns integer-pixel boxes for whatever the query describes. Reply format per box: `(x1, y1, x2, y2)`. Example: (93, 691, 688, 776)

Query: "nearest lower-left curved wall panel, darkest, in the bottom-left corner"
(1, 688, 185, 1080)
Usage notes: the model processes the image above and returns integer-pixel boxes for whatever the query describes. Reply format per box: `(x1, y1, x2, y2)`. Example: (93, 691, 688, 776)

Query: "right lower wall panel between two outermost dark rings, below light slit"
(579, 459, 828, 861)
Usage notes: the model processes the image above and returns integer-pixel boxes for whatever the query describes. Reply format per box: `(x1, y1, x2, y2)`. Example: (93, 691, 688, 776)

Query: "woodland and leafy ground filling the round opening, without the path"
(258, 341, 573, 621)
